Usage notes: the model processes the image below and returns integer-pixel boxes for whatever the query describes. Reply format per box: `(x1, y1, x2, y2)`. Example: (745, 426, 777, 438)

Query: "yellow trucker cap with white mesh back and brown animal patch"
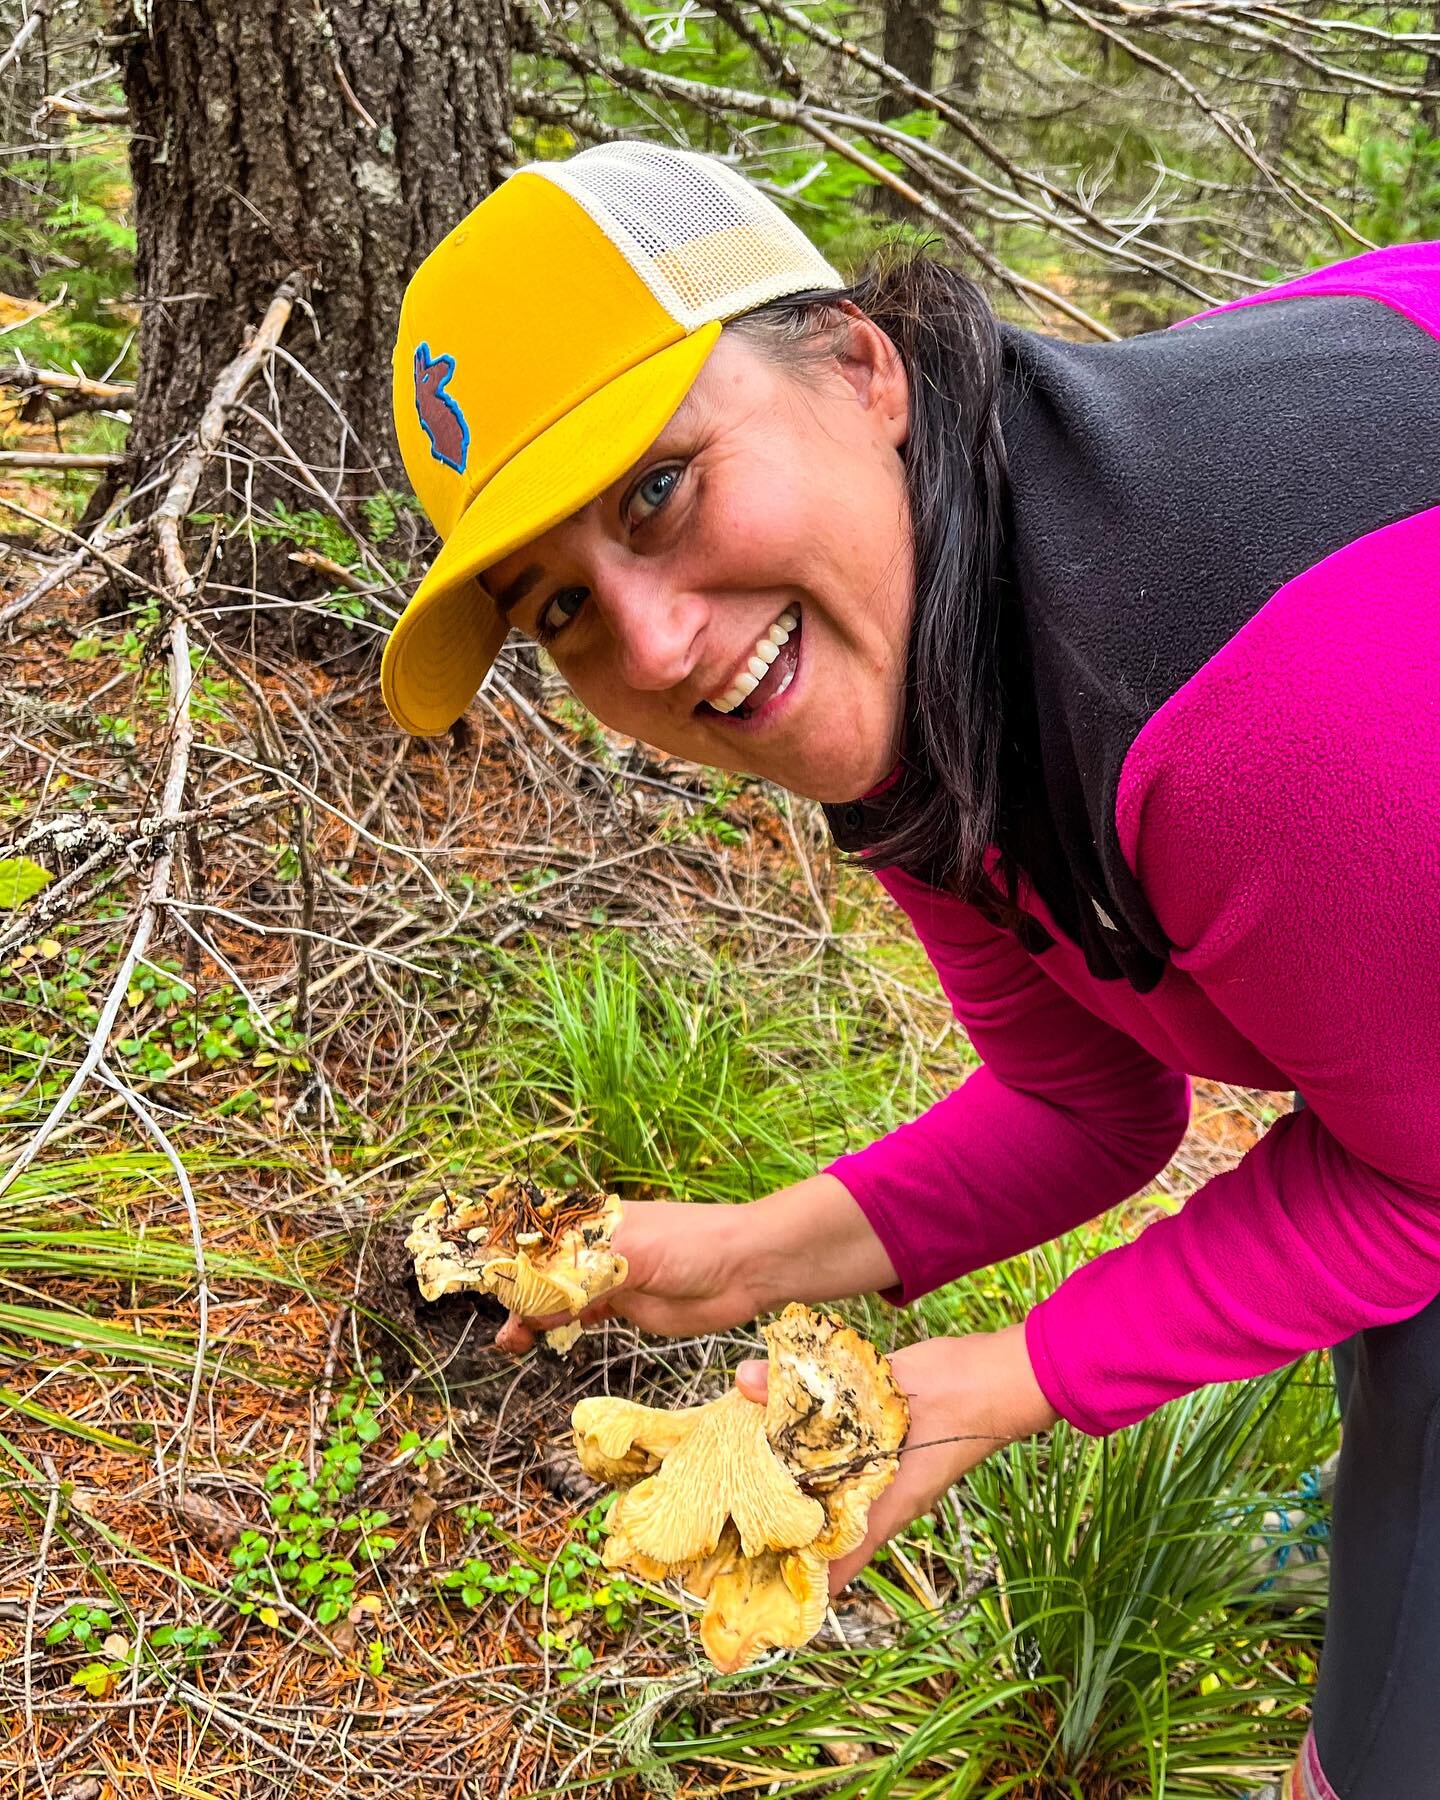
(380, 142, 842, 736)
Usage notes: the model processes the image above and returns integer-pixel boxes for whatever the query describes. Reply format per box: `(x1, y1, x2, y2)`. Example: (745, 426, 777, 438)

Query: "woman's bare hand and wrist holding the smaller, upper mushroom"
(495, 1174, 898, 1352)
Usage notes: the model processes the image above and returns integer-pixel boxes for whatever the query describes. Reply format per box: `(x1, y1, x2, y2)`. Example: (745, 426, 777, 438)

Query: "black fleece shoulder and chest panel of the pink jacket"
(1003, 297, 1440, 990)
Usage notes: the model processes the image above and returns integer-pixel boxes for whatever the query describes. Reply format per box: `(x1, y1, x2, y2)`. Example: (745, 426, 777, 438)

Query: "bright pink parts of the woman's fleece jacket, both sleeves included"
(832, 245, 1440, 1433)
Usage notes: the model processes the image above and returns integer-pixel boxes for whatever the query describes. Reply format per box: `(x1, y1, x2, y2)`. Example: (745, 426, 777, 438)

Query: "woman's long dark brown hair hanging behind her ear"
(727, 252, 1015, 911)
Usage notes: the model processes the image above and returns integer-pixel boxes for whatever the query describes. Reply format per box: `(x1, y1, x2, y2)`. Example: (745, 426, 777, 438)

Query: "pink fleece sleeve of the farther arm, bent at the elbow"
(830, 869, 1190, 1301)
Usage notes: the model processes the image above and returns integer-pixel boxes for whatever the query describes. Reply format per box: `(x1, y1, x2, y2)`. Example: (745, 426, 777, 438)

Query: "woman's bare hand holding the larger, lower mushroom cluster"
(736, 1325, 1057, 1595)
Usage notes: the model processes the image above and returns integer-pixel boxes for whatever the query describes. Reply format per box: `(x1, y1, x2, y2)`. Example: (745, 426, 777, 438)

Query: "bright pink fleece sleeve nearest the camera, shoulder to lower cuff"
(1028, 508, 1440, 1433)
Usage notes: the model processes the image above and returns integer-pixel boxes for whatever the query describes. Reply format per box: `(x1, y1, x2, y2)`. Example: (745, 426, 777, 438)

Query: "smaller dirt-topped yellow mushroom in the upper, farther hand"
(405, 1177, 626, 1350)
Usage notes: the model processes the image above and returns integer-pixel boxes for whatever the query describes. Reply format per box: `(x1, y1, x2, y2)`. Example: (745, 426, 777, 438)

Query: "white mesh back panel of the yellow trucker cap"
(518, 142, 844, 331)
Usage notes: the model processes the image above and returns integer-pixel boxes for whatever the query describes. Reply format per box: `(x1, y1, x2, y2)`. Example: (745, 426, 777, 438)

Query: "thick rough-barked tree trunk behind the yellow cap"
(121, 0, 511, 486)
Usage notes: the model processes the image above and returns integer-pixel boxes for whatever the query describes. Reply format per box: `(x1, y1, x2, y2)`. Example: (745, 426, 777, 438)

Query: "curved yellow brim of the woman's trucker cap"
(380, 322, 720, 736)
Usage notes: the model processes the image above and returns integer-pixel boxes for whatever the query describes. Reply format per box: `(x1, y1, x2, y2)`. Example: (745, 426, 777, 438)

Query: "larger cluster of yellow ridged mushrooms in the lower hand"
(572, 1305, 909, 1672)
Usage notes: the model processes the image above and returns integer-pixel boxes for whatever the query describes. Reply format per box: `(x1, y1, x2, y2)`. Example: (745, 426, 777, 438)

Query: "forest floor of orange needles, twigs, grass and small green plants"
(0, 561, 1314, 1800)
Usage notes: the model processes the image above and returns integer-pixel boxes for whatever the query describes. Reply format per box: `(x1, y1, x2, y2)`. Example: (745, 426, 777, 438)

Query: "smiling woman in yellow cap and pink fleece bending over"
(383, 144, 1440, 1800)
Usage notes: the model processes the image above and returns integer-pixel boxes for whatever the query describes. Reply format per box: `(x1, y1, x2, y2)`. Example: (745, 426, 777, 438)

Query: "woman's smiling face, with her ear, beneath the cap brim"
(482, 308, 914, 801)
